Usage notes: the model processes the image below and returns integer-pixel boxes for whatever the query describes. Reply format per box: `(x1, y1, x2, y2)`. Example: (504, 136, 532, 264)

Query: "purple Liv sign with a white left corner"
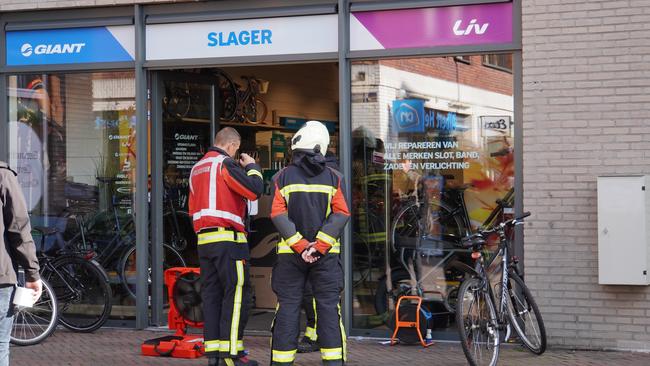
(350, 2, 513, 51)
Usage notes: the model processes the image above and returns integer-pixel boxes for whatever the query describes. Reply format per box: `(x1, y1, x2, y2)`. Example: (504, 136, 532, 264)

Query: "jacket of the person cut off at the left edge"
(0, 161, 40, 285)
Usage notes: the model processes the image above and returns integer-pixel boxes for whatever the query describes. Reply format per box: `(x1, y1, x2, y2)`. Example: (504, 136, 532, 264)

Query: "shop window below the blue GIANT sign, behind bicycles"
(7, 71, 136, 316)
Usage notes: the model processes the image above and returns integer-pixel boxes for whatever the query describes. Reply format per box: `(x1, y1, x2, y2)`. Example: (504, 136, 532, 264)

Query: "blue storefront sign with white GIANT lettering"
(6, 26, 135, 66)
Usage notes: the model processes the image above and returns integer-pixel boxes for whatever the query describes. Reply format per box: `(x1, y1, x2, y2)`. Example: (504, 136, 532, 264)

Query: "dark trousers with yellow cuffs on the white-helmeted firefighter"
(271, 254, 346, 365)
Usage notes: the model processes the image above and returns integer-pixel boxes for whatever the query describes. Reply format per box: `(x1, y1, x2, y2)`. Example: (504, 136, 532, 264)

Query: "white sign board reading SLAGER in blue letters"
(147, 14, 338, 61)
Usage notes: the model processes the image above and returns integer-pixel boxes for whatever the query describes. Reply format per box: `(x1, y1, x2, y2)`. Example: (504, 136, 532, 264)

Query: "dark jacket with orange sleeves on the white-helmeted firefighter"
(271, 150, 350, 254)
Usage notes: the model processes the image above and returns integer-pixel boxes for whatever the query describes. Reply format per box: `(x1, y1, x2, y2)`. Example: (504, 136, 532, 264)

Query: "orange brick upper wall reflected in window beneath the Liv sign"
(381, 55, 512, 95)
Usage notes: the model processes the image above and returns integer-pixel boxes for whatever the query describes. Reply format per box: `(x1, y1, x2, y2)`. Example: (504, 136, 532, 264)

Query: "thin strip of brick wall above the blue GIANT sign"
(0, 0, 182, 12)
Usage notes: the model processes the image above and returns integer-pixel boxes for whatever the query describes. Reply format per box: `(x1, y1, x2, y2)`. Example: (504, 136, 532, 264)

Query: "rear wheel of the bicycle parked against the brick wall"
(507, 272, 546, 355)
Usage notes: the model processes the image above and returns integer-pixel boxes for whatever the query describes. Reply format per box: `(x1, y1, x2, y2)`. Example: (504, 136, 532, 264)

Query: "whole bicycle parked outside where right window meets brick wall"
(456, 212, 546, 366)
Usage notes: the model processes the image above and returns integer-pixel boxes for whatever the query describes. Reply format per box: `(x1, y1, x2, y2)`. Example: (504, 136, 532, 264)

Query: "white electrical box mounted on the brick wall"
(598, 175, 650, 285)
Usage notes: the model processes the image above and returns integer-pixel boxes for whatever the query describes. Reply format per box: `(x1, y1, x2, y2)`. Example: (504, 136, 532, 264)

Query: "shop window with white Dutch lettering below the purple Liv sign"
(351, 55, 514, 334)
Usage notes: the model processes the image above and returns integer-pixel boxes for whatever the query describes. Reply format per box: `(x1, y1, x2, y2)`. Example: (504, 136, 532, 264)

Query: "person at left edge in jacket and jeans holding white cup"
(0, 161, 43, 366)
